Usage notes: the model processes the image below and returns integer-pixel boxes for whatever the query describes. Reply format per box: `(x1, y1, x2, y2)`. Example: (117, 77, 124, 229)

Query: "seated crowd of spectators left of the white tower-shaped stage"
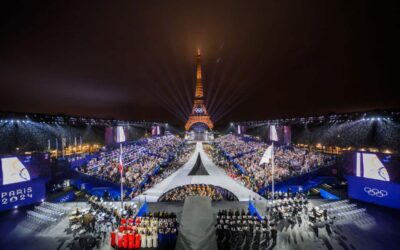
(77, 135, 184, 193)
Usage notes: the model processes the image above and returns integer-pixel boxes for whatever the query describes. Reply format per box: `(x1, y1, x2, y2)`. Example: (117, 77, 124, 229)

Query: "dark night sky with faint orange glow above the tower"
(0, 0, 400, 123)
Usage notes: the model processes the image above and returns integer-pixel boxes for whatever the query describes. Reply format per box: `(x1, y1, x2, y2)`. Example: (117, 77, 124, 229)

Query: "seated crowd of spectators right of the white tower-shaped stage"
(208, 134, 334, 192)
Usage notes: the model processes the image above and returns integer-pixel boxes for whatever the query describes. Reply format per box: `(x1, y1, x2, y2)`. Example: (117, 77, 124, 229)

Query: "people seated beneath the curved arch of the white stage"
(159, 184, 237, 201)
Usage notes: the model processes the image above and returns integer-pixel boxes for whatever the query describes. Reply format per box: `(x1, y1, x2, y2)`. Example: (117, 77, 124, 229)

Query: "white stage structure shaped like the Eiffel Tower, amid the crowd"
(135, 142, 264, 202)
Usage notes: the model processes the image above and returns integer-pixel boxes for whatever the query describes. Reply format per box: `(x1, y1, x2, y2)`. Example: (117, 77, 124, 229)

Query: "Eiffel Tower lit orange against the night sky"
(185, 49, 214, 131)
